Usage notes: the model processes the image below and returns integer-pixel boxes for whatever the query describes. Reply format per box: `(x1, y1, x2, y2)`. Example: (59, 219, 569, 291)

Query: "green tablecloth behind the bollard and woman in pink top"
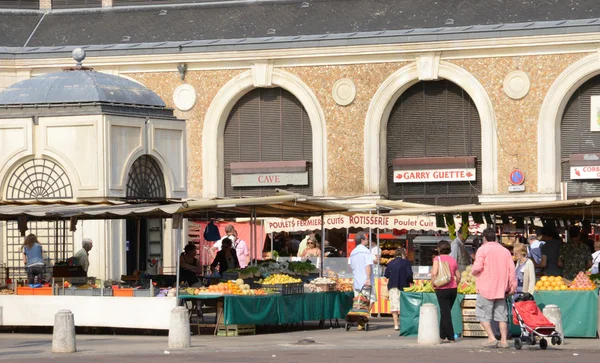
(400, 292, 465, 336)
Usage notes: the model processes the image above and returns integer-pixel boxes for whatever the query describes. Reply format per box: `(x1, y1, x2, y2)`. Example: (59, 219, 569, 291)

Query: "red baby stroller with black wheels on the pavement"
(512, 294, 562, 350)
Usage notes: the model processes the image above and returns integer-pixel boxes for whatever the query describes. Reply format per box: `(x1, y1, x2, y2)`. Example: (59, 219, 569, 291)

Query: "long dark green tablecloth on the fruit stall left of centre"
(224, 292, 354, 325)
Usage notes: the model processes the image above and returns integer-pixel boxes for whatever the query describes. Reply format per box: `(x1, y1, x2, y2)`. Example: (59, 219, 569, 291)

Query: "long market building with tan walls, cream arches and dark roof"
(0, 0, 600, 280)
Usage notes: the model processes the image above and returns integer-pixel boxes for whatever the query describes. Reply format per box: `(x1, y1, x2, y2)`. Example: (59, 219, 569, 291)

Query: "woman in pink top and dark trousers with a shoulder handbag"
(431, 240, 460, 343)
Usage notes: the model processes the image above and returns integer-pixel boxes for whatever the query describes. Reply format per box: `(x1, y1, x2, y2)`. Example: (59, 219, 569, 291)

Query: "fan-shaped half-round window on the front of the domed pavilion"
(6, 159, 73, 200)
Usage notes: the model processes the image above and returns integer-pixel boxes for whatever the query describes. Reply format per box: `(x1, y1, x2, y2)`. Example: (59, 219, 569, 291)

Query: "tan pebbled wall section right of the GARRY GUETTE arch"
(451, 53, 588, 194)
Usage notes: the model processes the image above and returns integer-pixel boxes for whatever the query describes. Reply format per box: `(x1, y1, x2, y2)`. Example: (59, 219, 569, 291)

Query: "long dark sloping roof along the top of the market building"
(0, 0, 600, 58)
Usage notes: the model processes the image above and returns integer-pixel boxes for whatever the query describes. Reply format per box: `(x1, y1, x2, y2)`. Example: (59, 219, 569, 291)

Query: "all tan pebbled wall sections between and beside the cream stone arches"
(127, 53, 588, 197)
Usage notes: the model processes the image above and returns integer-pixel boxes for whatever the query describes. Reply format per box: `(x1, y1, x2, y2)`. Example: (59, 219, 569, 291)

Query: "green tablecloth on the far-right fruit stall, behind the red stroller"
(533, 289, 598, 338)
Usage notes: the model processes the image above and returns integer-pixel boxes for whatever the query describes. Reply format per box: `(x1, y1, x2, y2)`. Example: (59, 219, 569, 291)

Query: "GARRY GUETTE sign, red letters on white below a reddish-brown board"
(394, 156, 477, 183)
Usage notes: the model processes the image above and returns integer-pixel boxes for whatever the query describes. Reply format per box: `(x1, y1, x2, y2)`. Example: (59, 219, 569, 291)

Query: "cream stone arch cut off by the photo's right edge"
(538, 52, 600, 199)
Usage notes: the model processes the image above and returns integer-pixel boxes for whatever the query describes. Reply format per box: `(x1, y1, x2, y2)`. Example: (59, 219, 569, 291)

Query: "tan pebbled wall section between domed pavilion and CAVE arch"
(127, 70, 243, 198)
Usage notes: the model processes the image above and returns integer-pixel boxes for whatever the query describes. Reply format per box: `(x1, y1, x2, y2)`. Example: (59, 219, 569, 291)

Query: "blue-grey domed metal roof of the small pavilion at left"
(0, 69, 166, 108)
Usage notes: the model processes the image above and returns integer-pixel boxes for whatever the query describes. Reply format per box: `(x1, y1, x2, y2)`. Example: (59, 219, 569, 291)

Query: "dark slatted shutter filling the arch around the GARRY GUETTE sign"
(386, 80, 482, 205)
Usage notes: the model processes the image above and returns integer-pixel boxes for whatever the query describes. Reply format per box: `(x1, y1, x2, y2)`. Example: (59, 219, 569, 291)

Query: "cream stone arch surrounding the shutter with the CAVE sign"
(202, 67, 327, 198)
